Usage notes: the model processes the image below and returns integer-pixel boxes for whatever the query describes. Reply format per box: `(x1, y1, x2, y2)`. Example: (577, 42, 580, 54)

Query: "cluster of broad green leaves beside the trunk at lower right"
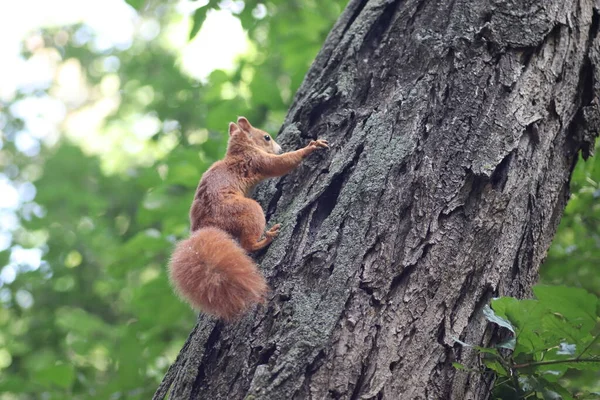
(454, 285, 600, 400)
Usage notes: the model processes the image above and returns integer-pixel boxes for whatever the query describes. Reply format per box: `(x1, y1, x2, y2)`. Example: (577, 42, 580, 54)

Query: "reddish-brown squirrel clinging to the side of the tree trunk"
(169, 117, 329, 321)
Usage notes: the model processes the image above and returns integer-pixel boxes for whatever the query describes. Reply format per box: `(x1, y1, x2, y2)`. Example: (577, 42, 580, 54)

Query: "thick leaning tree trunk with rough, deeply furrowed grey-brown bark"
(155, 0, 600, 400)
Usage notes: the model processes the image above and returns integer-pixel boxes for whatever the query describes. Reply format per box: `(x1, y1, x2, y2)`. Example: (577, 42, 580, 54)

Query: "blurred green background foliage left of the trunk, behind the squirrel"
(0, 0, 345, 399)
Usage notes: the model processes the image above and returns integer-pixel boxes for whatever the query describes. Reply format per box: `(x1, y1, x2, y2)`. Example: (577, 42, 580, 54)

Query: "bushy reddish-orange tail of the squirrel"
(169, 228, 268, 320)
